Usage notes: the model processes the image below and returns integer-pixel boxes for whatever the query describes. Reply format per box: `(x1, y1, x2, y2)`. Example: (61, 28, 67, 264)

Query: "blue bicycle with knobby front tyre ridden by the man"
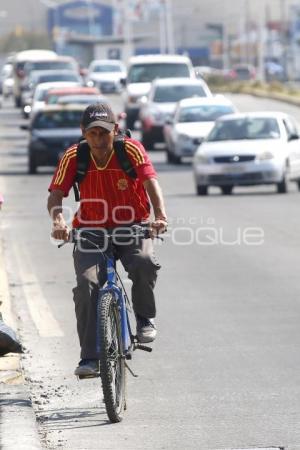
(58, 225, 162, 423)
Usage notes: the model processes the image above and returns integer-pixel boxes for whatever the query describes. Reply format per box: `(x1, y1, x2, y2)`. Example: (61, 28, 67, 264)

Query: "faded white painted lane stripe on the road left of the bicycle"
(14, 243, 64, 337)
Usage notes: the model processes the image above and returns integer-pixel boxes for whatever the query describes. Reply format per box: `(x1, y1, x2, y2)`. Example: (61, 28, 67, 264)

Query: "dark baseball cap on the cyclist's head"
(81, 103, 116, 131)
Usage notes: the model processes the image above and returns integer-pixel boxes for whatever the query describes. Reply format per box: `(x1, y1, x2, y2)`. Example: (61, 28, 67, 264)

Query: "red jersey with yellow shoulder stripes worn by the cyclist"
(49, 138, 156, 228)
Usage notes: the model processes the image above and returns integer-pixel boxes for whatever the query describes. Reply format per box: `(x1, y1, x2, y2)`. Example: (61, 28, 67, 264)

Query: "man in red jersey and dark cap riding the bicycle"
(48, 103, 167, 376)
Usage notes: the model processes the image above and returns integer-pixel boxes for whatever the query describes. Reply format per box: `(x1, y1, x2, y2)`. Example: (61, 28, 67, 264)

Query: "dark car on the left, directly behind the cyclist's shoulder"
(21, 105, 86, 174)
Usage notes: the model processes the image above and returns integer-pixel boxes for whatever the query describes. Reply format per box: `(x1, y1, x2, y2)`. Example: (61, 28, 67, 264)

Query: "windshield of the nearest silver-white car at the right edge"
(207, 117, 280, 142)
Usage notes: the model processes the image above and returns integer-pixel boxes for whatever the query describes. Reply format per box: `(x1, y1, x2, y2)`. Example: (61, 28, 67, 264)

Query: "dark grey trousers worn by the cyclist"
(73, 230, 160, 359)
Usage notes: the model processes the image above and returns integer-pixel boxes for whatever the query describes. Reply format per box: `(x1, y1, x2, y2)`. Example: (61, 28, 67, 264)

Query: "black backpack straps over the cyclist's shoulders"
(73, 130, 137, 202)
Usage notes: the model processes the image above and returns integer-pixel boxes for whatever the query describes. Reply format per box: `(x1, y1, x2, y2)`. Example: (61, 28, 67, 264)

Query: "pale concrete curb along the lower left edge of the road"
(0, 240, 42, 450)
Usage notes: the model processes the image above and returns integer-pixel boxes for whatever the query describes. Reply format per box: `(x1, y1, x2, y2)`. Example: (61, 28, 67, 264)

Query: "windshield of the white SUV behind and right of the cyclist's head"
(128, 63, 190, 83)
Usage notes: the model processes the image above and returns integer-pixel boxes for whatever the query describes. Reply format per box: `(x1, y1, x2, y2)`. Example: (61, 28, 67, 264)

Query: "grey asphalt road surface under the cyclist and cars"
(0, 96, 300, 450)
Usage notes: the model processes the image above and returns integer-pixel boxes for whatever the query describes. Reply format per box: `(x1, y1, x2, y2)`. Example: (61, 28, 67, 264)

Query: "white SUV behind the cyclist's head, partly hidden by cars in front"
(121, 55, 196, 128)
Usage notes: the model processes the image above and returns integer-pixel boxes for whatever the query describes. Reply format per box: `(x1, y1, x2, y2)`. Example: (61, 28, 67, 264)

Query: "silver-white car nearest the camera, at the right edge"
(193, 111, 300, 195)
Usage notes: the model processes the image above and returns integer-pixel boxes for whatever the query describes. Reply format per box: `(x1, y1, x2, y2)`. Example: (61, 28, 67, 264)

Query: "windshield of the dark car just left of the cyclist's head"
(32, 110, 82, 130)
